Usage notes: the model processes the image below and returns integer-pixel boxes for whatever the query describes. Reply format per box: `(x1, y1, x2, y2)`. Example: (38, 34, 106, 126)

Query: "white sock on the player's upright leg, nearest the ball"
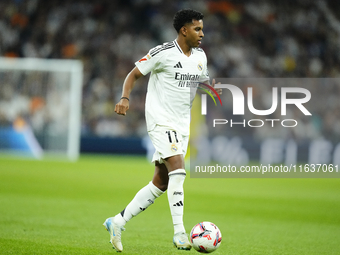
(168, 169, 186, 234)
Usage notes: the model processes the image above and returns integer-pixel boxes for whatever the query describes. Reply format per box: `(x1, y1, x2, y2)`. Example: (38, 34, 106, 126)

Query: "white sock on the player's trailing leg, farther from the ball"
(115, 182, 164, 226)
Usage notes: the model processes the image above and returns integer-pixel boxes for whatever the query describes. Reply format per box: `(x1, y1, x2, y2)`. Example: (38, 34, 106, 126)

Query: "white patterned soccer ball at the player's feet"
(190, 221, 222, 253)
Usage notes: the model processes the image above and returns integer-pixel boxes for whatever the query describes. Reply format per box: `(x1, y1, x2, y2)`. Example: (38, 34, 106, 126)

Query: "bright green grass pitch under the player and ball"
(0, 155, 340, 255)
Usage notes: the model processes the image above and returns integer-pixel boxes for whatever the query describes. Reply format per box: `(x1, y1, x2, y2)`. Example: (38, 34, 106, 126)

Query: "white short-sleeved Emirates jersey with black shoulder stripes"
(135, 40, 209, 135)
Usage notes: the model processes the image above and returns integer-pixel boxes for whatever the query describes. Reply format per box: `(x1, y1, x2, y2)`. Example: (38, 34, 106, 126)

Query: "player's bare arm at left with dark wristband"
(115, 67, 143, 115)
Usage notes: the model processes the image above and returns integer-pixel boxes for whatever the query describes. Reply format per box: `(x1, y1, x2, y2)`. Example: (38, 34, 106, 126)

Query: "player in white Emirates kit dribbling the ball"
(103, 10, 214, 252)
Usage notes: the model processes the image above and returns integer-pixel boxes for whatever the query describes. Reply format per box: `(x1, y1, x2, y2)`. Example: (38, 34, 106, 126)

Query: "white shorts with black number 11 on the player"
(148, 125, 189, 164)
